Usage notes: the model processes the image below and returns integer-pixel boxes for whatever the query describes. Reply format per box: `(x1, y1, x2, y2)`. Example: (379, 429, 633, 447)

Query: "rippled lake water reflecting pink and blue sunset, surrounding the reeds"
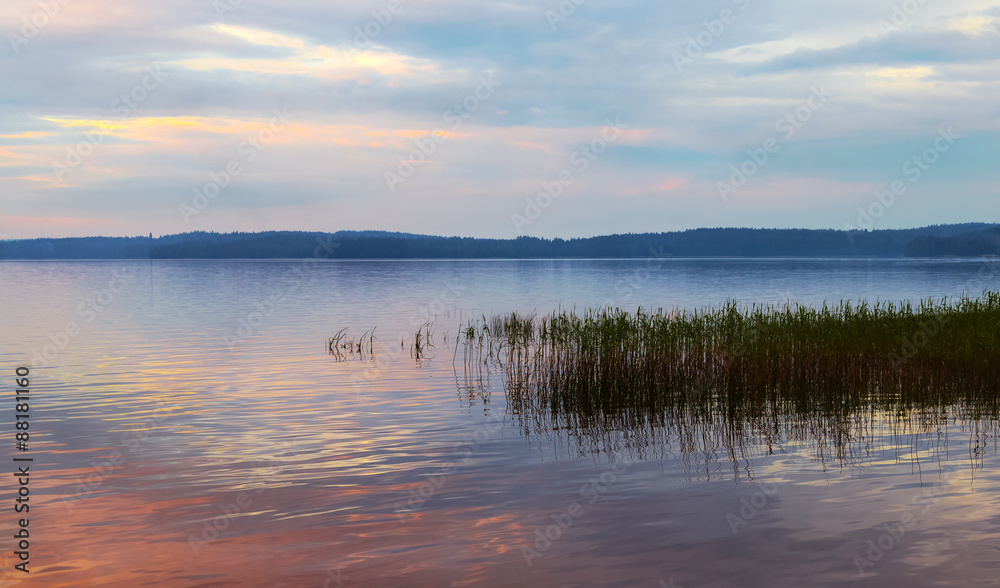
(0, 254, 1000, 588)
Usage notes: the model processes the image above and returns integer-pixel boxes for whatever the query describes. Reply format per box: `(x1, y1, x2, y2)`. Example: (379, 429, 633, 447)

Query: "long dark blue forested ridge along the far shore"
(0, 223, 1000, 259)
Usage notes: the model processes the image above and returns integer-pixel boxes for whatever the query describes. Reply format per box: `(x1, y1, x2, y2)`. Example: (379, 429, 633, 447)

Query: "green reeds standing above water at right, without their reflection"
(467, 291, 1000, 399)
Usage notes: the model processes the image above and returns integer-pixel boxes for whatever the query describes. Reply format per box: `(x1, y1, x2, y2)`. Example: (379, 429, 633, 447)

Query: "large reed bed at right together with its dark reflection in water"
(460, 291, 1000, 463)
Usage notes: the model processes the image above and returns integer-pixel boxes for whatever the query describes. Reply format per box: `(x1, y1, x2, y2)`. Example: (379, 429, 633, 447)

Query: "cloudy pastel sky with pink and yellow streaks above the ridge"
(0, 0, 1000, 238)
